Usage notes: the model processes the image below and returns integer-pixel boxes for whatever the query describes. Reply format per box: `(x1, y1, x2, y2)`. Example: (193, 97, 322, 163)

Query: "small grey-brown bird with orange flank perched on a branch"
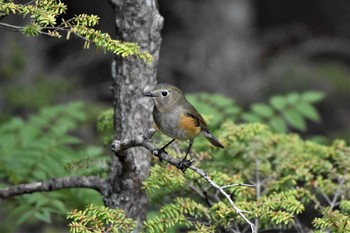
(144, 83, 224, 172)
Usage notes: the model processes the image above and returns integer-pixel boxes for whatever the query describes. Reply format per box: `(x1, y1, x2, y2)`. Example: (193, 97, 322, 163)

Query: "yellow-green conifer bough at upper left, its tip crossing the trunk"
(0, 0, 152, 62)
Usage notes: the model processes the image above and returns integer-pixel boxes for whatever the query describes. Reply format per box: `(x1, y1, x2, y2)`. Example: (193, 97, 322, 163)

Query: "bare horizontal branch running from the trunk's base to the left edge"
(0, 176, 107, 199)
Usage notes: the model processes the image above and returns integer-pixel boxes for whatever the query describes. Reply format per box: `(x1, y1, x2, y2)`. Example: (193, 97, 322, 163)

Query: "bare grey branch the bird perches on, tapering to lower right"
(111, 129, 256, 233)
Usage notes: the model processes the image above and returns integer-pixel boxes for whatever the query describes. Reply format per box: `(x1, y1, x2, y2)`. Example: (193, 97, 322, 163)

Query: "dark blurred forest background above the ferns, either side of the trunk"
(0, 0, 350, 141)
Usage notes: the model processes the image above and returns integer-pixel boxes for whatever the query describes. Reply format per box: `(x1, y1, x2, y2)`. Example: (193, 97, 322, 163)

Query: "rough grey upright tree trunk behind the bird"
(104, 0, 163, 226)
